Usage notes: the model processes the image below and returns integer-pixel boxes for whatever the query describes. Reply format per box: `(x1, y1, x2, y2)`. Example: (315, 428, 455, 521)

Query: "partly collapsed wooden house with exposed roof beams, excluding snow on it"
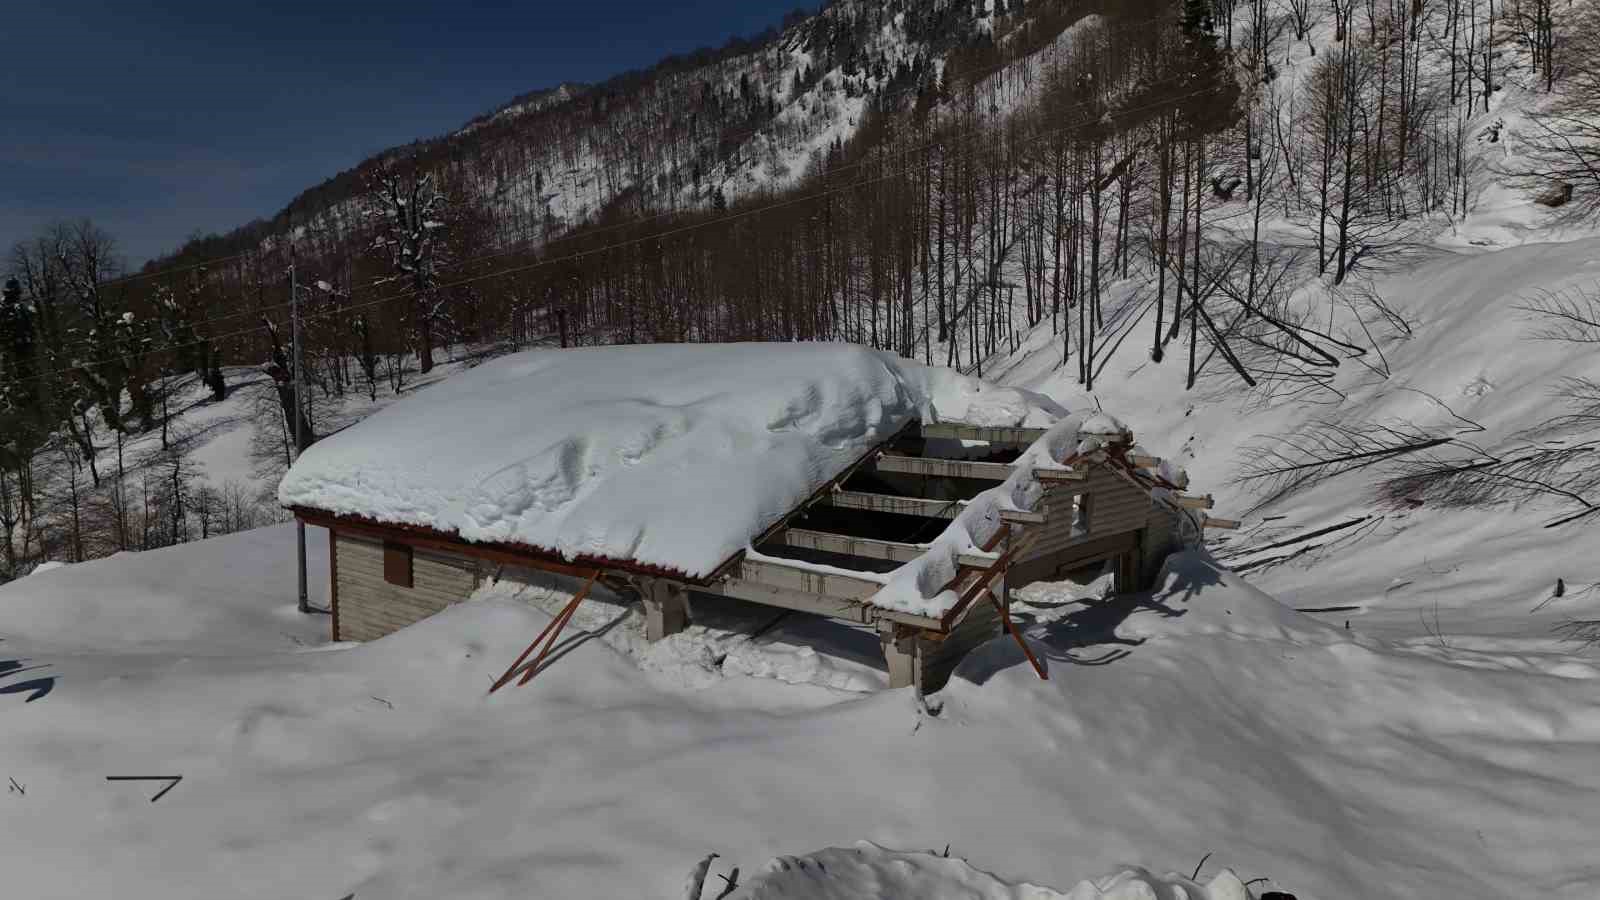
(293, 421, 1237, 692)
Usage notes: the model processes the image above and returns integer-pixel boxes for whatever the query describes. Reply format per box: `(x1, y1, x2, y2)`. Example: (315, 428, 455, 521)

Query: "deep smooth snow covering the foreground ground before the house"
(0, 527, 1600, 900)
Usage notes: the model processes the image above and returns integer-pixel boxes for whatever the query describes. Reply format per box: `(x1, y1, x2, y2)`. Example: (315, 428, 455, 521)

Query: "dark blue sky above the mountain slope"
(0, 0, 800, 267)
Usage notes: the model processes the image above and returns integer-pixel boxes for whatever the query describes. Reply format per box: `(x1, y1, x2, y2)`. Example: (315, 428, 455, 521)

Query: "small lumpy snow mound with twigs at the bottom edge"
(730, 841, 1250, 900)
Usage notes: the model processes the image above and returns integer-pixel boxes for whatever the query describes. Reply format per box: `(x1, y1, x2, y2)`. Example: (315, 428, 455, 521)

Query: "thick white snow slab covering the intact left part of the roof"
(278, 344, 1066, 577)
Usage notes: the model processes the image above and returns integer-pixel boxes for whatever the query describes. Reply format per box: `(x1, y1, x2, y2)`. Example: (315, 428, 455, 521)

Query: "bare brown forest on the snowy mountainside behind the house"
(0, 0, 1600, 580)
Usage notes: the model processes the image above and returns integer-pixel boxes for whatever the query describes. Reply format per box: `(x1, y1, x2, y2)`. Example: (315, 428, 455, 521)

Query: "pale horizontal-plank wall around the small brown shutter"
(333, 532, 480, 641)
